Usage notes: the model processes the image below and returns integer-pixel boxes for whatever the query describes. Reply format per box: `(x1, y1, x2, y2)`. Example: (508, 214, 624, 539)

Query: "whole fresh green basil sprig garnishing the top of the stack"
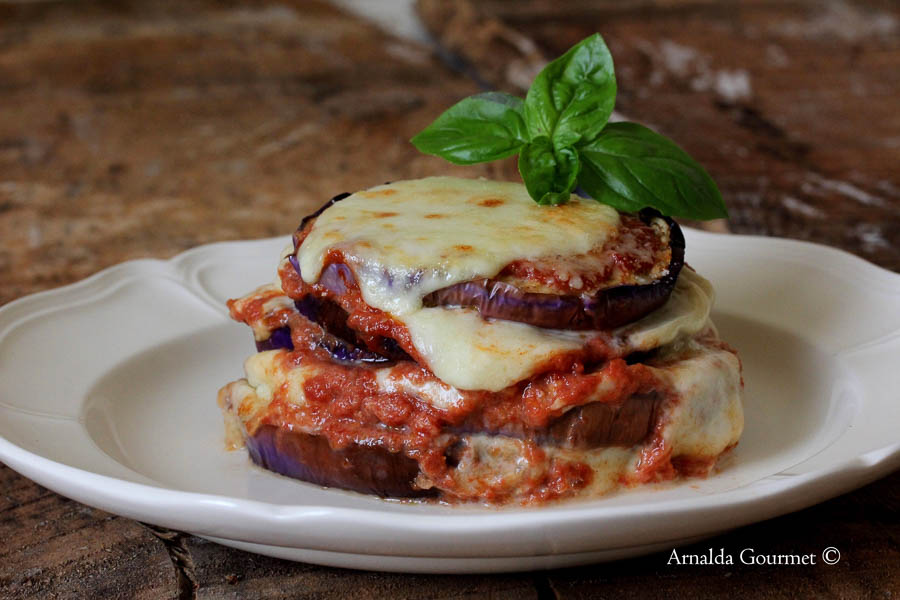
(412, 34, 728, 219)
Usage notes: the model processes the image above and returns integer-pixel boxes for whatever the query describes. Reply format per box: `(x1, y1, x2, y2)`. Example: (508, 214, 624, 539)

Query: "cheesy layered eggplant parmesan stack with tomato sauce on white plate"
(219, 177, 743, 504)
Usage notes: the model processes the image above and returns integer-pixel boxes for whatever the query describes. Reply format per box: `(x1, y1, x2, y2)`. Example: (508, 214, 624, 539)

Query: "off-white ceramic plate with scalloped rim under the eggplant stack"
(0, 230, 900, 572)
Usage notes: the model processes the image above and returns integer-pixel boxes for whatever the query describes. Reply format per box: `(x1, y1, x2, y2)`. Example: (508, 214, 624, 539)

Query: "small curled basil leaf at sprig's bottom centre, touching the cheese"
(519, 136, 581, 205)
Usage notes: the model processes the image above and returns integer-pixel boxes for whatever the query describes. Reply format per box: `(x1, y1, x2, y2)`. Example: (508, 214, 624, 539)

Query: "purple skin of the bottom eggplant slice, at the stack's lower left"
(246, 425, 436, 498)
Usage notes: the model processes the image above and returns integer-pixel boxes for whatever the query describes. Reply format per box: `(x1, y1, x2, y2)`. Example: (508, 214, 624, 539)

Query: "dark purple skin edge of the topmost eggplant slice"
(423, 209, 684, 330)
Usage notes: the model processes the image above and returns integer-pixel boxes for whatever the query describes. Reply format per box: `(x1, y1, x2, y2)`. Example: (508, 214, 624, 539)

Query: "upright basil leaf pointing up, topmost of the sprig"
(525, 33, 616, 148)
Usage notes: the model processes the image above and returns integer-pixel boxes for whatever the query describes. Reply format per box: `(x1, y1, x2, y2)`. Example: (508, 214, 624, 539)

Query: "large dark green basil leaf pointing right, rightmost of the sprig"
(578, 123, 728, 220)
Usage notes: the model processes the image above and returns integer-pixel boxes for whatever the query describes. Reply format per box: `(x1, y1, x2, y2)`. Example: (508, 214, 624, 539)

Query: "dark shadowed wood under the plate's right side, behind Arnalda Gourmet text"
(548, 474, 900, 600)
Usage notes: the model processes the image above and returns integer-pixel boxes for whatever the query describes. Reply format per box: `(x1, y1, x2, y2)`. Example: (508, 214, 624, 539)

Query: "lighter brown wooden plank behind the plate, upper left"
(0, 0, 515, 303)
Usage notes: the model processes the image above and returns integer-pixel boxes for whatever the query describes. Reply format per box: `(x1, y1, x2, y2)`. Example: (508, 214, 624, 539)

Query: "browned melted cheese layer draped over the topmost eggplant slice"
(297, 177, 619, 316)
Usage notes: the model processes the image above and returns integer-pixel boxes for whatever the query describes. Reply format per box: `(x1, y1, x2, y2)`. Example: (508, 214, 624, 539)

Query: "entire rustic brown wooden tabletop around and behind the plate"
(0, 0, 900, 599)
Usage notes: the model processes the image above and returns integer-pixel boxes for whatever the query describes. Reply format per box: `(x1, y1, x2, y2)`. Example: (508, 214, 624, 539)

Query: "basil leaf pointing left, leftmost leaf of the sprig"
(410, 92, 528, 165)
